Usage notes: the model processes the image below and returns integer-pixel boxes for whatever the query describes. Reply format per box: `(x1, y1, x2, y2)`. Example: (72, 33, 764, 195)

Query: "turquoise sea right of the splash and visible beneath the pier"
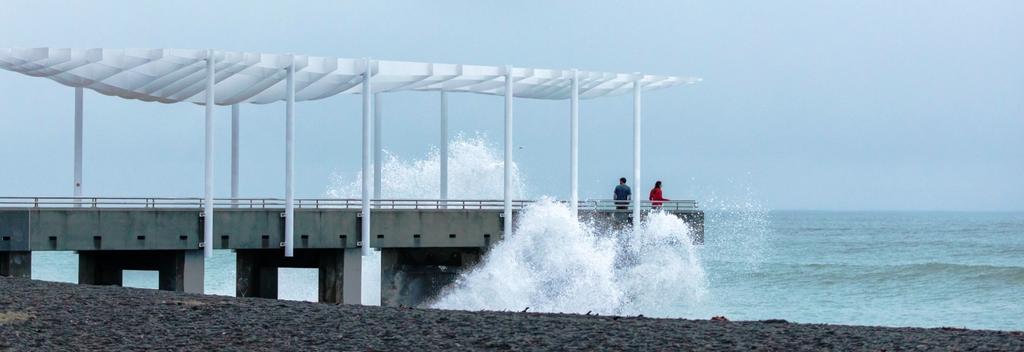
(33, 211, 1024, 331)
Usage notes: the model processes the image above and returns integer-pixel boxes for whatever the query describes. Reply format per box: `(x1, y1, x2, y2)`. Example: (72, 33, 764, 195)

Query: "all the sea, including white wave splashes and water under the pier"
(33, 136, 1024, 329)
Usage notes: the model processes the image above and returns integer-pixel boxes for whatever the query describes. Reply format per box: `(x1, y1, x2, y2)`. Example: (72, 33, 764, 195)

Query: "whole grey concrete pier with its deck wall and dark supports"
(0, 199, 703, 306)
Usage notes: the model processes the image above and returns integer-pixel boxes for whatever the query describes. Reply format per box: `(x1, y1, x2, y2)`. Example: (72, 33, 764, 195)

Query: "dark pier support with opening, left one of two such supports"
(78, 250, 205, 294)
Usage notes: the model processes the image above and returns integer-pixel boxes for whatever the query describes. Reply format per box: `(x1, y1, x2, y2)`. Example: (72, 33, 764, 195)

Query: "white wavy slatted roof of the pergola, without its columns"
(0, 48, 699, 105)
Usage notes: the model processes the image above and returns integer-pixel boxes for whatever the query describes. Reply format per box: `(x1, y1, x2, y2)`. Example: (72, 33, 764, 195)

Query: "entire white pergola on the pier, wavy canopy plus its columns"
(0, 48, 700, 266)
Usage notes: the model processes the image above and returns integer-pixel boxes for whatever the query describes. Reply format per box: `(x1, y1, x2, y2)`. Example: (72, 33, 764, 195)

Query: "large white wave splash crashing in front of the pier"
(432, 200, 707, 316)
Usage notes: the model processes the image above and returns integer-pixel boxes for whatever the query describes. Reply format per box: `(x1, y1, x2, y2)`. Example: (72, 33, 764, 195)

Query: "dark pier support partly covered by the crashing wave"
(381, 248, 483, 307)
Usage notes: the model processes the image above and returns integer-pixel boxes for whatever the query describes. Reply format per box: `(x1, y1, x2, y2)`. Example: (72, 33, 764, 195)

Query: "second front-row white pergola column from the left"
(285, 57, 295, 257)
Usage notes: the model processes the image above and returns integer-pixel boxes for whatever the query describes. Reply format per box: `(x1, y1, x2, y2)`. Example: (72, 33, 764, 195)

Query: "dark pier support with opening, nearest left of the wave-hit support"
(234, 249, 361, 304)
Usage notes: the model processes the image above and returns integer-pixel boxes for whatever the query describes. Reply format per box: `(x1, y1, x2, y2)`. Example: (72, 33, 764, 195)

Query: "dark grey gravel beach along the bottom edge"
(0, 277, 1024, 351)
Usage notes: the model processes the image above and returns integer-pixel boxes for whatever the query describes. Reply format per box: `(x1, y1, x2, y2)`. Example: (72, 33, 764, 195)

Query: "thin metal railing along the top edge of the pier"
(0, 196, 697, 212)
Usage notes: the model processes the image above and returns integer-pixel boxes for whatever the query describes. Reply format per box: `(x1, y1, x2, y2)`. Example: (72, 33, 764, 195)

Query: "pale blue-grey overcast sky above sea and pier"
(0, 0, 1024, 211)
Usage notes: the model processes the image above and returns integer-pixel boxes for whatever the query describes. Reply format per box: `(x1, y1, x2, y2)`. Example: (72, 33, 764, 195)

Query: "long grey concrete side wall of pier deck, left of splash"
(0, 208, 516, 251)
